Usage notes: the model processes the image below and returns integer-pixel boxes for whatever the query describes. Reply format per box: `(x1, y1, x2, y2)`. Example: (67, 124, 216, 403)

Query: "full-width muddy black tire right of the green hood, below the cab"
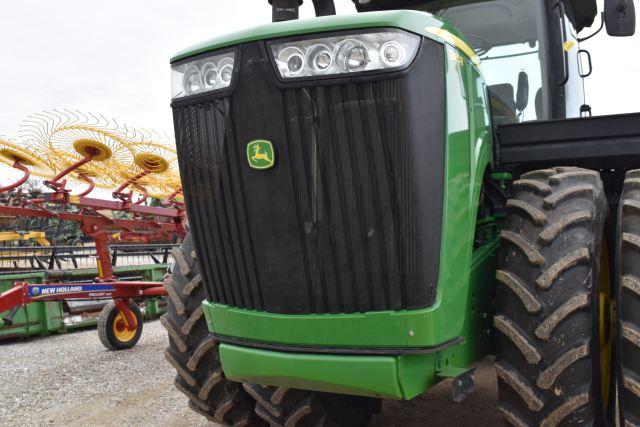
(494, 168, 608, 426)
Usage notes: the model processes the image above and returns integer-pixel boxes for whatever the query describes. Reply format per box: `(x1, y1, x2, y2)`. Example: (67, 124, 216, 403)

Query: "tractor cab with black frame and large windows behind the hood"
(354, 0, 632, 124)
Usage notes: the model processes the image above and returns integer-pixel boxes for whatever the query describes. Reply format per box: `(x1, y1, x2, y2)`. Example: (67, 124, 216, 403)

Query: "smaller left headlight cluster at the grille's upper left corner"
(171, 52, 235, 99)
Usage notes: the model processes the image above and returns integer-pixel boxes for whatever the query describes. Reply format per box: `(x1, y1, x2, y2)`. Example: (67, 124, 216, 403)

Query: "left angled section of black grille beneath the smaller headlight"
(175, 98, 264, 309)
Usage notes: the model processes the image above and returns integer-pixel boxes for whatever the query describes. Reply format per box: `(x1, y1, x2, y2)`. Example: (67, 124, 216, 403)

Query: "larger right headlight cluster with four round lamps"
(269, 29, 420, 79)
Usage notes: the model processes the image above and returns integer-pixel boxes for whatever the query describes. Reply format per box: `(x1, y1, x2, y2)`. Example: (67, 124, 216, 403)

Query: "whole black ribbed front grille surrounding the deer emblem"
(174, 39, 444, 314)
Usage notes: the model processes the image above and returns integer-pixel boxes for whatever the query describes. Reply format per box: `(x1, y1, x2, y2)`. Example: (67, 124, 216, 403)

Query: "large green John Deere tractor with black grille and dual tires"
(162, 0, 640, 427)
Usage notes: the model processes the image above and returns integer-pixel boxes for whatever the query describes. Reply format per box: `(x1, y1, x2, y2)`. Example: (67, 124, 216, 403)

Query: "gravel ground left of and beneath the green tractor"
(0, 320, 501, 427)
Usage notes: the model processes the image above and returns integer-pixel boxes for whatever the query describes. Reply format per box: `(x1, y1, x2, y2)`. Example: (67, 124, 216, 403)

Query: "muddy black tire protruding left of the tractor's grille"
(160, 235, 265, 426)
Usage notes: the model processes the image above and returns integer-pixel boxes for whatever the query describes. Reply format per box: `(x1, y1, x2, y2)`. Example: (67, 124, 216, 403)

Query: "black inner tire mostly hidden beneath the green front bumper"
(244, 383, 381, 427)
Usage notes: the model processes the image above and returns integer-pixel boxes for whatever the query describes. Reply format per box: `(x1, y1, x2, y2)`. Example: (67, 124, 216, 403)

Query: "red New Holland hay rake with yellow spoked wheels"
(0, 112, 185, 350)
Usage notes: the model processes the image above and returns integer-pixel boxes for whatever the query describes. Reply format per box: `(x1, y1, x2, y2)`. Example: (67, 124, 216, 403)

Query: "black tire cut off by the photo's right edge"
(616, 170, 640, 426)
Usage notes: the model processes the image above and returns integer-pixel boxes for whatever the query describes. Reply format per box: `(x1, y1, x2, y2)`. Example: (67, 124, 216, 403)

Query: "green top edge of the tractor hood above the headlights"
(171, 10, 468, 62)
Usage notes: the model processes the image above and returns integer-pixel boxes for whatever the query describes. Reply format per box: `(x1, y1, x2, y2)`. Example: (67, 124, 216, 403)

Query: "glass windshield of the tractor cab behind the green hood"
(412, 0, 549, 123)
